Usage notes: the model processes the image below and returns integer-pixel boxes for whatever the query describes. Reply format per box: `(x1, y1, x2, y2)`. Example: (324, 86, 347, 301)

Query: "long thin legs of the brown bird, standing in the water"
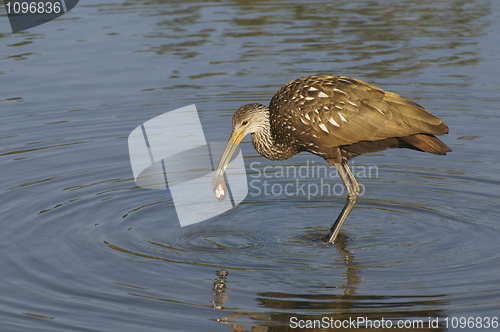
(328, 161, 360, 243)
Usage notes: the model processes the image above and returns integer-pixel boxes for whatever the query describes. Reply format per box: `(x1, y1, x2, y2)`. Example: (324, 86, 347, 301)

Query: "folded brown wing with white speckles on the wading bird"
(270, 76, 448, 147)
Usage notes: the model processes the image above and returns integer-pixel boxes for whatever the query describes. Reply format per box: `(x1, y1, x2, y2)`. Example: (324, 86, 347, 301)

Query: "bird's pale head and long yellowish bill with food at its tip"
(212, 103, 269, 201)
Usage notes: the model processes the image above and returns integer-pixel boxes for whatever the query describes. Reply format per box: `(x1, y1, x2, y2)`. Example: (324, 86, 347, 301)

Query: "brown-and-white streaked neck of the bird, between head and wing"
(252, 109, 297, 160)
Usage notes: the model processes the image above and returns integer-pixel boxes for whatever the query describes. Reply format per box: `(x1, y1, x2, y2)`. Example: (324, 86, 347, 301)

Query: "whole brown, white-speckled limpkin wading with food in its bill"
(212, 76, 451, 243)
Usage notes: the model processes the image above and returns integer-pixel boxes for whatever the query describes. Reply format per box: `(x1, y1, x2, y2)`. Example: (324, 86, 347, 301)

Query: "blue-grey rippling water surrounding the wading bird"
(0, 0, 500, 331)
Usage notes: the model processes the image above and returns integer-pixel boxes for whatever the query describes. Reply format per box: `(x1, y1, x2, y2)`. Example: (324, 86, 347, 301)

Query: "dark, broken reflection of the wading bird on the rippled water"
(212, 235, 448, 332)
